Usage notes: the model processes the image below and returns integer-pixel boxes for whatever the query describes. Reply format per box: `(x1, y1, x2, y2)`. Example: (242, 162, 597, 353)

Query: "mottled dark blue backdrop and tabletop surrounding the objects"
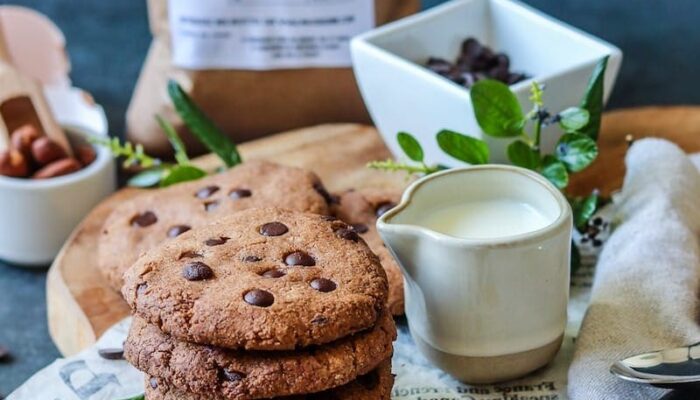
(0, 0, 700, 394)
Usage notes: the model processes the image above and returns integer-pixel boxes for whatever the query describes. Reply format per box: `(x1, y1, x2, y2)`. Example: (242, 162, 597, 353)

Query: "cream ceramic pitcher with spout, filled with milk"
(377, 165, 573, 383)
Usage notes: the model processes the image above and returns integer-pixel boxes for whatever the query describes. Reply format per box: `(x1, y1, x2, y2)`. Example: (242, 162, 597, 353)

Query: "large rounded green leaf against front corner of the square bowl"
(470, 79, 525, 137)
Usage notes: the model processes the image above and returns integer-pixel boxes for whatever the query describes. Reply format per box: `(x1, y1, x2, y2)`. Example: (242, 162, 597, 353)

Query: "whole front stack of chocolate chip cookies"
(123, 208, 396, 400)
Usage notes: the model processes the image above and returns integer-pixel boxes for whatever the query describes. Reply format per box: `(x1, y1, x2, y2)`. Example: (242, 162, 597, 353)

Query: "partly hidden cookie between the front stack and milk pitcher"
(331, 189, 404, 315)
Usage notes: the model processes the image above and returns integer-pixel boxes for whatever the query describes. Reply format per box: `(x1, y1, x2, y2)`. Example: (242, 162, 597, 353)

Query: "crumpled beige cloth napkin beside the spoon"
(568, 139, 700, 400)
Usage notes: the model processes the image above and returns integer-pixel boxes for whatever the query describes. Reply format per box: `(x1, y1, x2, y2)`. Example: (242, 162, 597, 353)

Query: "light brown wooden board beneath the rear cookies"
(47, 107, 700, 356)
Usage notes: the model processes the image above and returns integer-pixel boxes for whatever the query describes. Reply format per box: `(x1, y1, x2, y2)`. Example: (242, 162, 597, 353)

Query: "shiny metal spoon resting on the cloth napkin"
(610, 342, 700, 389)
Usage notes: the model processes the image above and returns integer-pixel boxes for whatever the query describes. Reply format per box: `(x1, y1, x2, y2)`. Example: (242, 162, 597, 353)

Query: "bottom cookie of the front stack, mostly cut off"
(145, 360, 394, 400)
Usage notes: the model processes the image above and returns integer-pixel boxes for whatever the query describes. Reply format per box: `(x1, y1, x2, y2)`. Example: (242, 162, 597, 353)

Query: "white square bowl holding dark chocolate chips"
(351, 0, 622, 166)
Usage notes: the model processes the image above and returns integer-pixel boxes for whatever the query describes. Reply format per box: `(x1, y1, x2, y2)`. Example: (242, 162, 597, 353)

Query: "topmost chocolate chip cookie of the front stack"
(122, 208, 388, 350)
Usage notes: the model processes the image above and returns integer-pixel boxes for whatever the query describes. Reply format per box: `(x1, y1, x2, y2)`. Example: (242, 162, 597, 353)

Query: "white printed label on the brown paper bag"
(168, 0, 374, 70)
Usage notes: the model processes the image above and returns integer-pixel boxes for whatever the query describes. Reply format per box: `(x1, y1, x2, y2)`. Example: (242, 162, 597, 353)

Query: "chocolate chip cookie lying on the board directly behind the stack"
(98, 161, 332, 290)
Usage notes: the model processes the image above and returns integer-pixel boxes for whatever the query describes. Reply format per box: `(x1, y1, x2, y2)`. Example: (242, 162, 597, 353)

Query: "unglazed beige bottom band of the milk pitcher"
(412, 335, 564, 384)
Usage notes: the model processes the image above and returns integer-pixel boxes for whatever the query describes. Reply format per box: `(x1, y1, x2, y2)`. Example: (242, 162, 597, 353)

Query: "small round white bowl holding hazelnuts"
(0, 127, 116, 267)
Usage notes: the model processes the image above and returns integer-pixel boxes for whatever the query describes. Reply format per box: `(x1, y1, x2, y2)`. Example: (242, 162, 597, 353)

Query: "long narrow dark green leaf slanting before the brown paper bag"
(168, 80, 242, 167)
